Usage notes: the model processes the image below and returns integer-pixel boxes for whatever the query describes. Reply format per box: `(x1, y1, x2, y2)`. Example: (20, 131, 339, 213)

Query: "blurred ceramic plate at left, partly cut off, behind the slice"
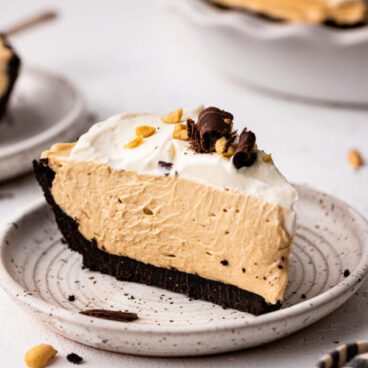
(0, 68, 86, 181)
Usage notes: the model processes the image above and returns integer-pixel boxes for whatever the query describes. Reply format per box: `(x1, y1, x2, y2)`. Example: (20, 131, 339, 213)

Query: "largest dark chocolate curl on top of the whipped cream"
(187, 107, 233, 153)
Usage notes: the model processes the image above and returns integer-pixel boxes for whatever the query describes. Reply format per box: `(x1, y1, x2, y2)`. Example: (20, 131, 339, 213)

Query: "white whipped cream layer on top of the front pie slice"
(69, 106, 297, 209)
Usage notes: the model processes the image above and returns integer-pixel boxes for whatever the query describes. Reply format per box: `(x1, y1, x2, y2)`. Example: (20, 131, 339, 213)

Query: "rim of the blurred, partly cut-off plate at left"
(0, 65, 84, 160)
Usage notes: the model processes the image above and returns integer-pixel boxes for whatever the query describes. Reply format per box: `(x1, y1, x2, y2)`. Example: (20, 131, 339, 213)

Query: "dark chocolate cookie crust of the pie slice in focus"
(33, 159, 281, 315)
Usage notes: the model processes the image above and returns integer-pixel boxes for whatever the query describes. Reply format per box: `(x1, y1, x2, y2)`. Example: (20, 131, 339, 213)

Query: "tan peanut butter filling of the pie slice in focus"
(42, 144, 292, 303)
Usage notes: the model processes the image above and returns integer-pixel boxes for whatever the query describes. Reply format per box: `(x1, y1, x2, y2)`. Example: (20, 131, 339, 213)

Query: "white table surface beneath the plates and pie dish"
(0, 0, 368, 368)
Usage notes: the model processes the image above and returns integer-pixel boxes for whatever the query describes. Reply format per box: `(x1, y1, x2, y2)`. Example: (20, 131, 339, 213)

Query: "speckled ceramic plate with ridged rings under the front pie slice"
(0, 186, 368, 356)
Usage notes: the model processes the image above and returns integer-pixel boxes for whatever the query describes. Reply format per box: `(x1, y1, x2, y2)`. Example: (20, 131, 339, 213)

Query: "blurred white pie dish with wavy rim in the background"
(167, 0, 368, 105)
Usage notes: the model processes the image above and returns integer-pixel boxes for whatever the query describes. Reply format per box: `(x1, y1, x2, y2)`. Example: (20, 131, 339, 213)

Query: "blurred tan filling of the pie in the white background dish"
(211, 0, 367, 25)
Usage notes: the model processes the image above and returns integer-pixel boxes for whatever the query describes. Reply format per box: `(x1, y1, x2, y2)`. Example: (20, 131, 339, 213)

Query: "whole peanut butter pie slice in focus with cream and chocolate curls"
(34, 107, 297, 314)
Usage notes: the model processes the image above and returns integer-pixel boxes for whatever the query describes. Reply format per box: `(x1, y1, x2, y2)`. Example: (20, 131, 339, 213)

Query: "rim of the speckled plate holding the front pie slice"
(0, 184, 368, 335)
